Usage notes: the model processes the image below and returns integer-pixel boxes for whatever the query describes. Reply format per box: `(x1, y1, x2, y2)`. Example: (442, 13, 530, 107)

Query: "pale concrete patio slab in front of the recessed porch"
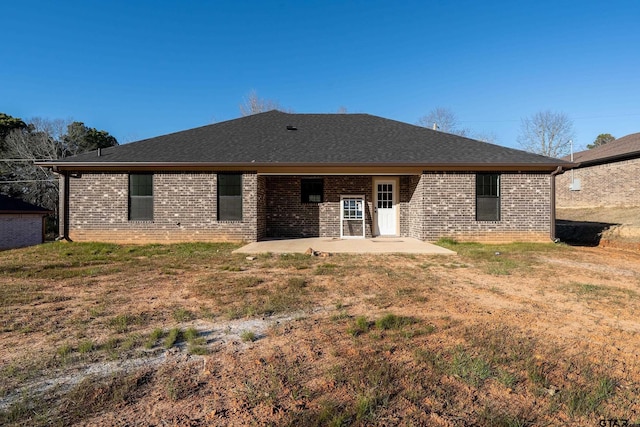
(233, 237, 456, 255)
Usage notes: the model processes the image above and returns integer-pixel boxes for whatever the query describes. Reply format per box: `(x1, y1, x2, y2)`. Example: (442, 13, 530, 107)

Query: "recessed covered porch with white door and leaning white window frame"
(257, 172, 420, 241)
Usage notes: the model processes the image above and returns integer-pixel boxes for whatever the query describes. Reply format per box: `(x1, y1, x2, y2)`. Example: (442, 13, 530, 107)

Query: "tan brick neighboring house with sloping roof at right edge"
(556, 133, 640, 208)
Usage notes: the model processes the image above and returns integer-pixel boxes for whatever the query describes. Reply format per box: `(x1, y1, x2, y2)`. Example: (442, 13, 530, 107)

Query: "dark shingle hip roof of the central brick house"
(47, 111, 566, 168)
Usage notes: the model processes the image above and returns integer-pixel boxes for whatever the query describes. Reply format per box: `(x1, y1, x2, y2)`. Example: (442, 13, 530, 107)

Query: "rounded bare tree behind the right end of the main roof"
(518, 110, 573, 157)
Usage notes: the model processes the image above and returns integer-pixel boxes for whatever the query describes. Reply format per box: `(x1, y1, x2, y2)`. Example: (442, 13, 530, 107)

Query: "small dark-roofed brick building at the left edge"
(0, 194, 51, 250)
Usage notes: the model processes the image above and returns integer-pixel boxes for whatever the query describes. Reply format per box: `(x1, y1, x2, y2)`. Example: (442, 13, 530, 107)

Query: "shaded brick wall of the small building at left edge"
(0, 214, 44, 250)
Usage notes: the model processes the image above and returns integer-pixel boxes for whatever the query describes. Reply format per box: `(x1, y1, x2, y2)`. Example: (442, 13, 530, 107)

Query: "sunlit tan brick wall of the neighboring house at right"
(556, 158, 640, 208)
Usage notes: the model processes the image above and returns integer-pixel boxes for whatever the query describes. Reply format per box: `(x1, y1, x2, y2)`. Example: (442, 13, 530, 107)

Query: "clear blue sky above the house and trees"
(0, 0, 640, 152)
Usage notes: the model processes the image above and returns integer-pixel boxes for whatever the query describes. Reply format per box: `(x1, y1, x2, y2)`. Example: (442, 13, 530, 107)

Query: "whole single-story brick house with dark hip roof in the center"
(40, 111, 572, 243)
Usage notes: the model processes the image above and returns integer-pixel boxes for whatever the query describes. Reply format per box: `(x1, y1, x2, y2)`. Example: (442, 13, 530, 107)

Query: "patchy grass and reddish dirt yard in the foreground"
(0, 242, 640, 426)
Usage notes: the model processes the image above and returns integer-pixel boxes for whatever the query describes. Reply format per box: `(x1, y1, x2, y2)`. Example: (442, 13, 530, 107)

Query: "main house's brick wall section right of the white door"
(418, 173, 551, 242)
